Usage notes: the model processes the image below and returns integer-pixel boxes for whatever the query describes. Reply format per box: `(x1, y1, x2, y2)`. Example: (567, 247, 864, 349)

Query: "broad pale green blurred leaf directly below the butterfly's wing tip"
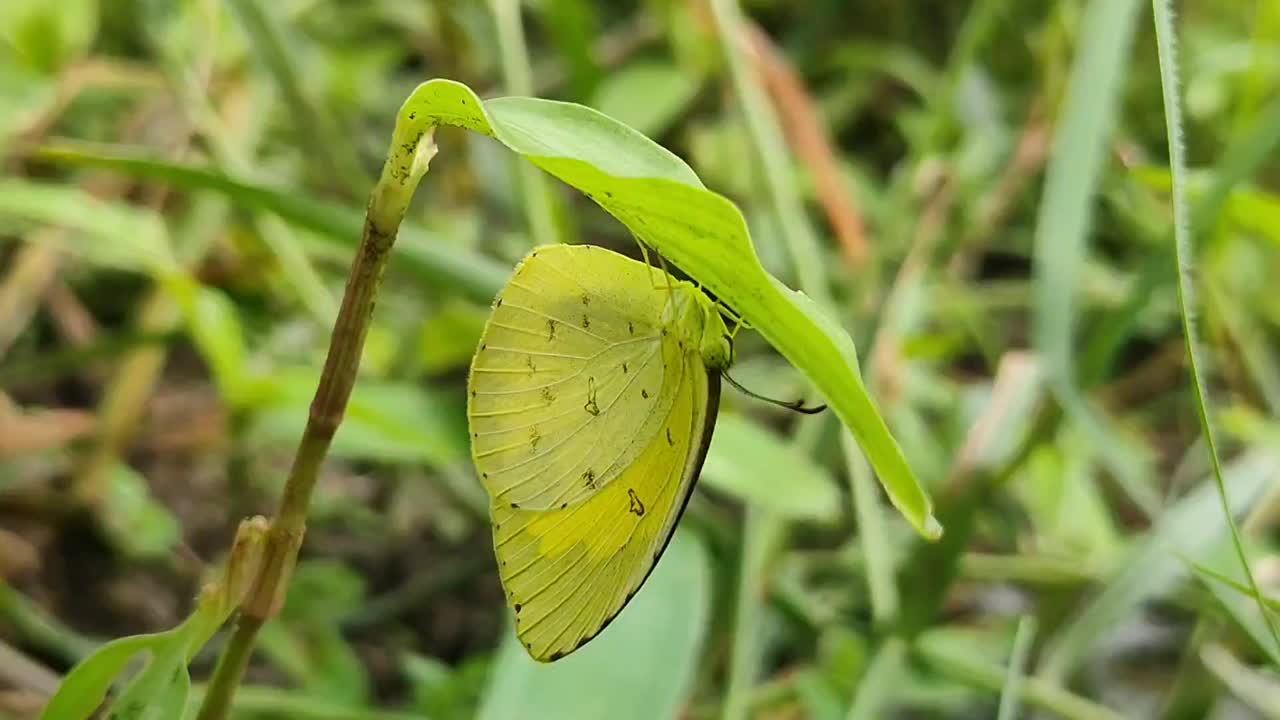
(479, 530, 712, 720)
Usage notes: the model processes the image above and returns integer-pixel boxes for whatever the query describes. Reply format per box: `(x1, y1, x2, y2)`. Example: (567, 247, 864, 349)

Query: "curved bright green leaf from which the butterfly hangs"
(375, 79, 942, 538)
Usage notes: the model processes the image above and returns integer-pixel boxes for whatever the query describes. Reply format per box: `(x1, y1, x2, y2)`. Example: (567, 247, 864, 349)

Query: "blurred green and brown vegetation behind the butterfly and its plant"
(0, 0, 1280, 719)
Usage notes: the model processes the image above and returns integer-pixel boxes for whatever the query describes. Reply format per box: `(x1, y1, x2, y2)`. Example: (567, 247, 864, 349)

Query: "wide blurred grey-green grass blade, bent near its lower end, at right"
(1033, 0, 1158, 515)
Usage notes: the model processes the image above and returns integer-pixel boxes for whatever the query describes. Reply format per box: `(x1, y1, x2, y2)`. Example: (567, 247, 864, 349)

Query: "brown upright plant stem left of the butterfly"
(197, 111, 435, 720)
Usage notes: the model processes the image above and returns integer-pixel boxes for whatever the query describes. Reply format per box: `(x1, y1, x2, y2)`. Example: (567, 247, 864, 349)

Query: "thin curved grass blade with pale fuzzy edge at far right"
(1152, 0, 1280, 648)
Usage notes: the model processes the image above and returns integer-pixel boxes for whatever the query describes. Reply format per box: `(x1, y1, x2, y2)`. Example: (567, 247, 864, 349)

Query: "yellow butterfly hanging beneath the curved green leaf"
(467, 245, 732, 661)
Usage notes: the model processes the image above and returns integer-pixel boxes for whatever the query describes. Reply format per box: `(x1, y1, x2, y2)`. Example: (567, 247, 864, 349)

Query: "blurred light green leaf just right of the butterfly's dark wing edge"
(703, 411, 842, 523)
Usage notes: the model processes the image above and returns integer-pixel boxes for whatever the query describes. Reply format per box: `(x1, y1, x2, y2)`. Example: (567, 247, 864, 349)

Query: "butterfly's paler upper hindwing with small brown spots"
(467, 245, 685, 510)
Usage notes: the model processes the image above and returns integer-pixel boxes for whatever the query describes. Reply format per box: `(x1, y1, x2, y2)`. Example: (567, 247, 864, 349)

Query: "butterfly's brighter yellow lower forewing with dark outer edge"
(492, 352, 719, 661)
